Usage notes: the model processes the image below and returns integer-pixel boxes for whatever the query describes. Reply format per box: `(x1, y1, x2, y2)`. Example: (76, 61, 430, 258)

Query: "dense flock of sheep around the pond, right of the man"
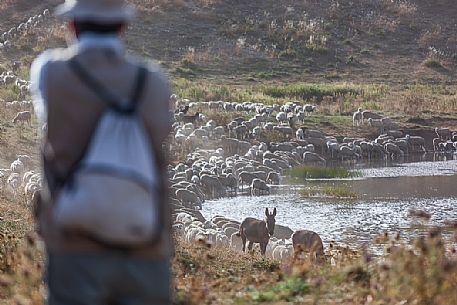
(165, 96, 457, 259)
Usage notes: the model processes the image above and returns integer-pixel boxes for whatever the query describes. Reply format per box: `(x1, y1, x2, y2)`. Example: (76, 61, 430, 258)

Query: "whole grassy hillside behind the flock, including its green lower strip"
(0, 0, 457, 166)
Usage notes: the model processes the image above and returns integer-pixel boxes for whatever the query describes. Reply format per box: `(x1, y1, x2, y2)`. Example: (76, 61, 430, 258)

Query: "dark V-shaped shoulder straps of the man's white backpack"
(69, 58, 147, 114)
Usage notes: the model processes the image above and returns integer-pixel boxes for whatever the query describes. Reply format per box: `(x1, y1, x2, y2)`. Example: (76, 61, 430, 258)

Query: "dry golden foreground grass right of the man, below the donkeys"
(173, 230, 457, 305)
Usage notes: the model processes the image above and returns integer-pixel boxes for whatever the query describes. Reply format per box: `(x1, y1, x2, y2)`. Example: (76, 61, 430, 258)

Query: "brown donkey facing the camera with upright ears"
(237, 208, 276, 255)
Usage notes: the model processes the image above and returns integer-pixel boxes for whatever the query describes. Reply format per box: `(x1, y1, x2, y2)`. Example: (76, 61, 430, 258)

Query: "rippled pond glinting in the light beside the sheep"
(202, 154, 457, 252)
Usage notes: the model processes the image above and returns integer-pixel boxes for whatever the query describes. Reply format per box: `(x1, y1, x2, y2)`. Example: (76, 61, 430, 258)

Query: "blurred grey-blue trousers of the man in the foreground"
(47, 253, 171, 305)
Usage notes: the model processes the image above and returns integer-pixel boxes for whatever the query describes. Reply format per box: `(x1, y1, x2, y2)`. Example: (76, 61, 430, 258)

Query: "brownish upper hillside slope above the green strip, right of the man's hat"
(125, 0, 456, 85)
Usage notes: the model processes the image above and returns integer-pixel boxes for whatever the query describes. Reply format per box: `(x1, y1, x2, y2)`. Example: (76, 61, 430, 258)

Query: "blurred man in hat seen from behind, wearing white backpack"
(31, 0, 172, 305)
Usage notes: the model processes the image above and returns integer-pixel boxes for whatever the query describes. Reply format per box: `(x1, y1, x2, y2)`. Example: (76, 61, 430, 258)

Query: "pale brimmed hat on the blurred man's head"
(55, 0, 135, 23)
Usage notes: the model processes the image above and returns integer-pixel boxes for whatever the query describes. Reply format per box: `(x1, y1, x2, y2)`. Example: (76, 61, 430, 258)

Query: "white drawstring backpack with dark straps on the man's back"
(54, 60, 162, 247)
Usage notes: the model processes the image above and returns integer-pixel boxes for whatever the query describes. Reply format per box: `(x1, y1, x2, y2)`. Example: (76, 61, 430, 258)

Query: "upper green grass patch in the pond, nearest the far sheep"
(290, 166, 360, 179)
